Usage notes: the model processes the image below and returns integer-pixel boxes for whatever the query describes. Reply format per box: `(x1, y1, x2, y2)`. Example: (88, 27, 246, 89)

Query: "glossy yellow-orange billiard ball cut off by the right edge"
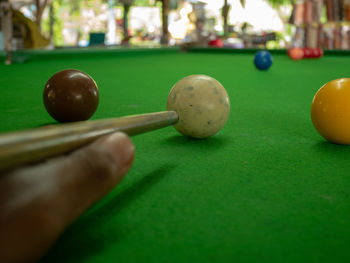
(311, 78, 350, 144)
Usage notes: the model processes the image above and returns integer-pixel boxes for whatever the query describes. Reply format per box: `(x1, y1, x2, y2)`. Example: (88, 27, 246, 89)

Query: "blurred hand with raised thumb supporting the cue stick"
(0, 133, 134, 262)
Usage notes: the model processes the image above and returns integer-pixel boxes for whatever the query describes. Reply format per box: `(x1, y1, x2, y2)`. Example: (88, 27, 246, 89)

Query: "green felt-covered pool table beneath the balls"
(0, 47, 350, 263)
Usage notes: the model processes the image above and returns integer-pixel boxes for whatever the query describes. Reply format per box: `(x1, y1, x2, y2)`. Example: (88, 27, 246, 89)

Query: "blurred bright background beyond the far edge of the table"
(0, 0, 350, 50)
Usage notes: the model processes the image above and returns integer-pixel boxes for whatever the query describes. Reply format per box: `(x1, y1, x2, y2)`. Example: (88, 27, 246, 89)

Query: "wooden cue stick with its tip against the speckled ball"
(0, 111, 179, 172)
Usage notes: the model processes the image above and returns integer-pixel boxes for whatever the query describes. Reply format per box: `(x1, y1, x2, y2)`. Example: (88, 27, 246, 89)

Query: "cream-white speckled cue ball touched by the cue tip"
(167, 75, 230, 139)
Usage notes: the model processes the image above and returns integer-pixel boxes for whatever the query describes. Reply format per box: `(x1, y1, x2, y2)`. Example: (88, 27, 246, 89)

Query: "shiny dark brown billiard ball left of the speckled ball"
(43, 69, 99, 122)
